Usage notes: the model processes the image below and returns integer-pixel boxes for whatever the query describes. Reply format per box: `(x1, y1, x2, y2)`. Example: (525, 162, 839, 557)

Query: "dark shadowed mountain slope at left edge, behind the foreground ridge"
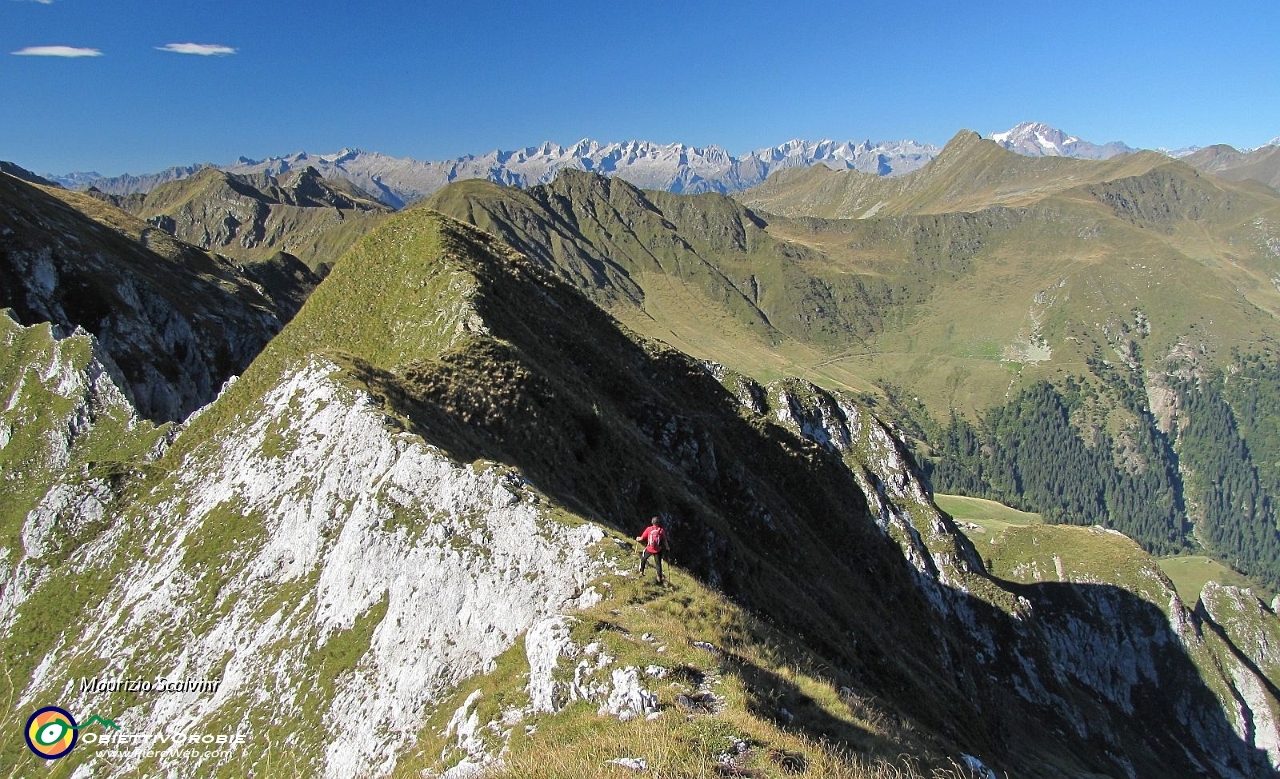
(0, 168, 307, 421)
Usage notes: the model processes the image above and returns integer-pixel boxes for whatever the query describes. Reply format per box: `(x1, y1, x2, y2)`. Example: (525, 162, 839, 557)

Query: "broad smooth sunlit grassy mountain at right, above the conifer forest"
(774, 161, 1280, 411)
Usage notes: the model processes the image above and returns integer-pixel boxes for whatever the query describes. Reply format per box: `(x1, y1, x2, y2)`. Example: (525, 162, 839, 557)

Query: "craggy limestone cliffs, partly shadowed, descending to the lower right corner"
(747, 366, 1280, 776)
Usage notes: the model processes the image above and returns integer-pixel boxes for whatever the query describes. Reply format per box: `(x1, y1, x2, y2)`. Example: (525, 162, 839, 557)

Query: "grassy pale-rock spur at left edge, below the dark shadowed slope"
(0, 311, 161, 634)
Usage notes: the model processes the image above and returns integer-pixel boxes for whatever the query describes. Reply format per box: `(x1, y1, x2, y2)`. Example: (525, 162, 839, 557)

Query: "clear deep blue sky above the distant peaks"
(0, 0, 1280, 175)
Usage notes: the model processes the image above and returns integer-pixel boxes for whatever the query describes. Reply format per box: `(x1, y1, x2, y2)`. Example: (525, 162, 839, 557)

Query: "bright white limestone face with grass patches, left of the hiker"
(3, 361, 604, 776)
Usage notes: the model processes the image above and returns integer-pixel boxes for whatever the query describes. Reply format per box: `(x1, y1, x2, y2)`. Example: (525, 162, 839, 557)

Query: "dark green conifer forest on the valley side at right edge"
(916, 357, 1280, 587)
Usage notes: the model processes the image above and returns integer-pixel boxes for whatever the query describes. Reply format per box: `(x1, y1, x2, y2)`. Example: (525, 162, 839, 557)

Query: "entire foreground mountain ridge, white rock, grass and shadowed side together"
(0, 209, 1271, 776)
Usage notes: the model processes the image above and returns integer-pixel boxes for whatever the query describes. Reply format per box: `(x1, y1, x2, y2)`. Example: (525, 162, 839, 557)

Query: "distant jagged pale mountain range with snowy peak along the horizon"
(45, 122, 1280, 209)
